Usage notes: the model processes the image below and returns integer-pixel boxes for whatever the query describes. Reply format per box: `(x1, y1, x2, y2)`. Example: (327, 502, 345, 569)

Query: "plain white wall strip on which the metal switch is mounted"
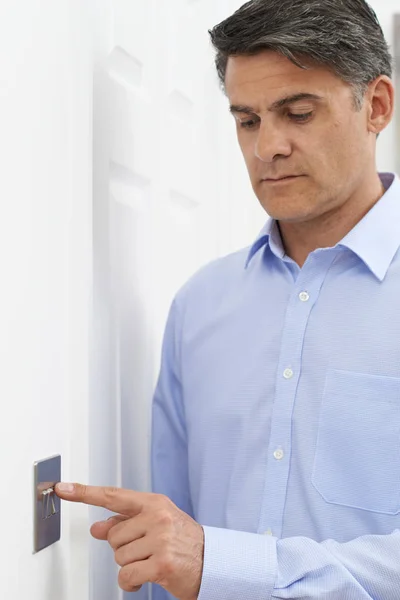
(0, 0, 92, 600)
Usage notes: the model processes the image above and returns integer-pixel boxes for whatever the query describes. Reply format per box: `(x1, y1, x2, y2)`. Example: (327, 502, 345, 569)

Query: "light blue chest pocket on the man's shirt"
(312, 370, 400, 515)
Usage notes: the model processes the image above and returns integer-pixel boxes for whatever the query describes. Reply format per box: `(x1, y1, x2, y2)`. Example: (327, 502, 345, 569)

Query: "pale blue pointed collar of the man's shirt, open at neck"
(245, 173, 400, 281)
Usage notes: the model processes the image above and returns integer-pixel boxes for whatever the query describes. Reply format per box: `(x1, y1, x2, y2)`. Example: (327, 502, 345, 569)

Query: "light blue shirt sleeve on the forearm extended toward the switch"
(198, 527, 400, 600)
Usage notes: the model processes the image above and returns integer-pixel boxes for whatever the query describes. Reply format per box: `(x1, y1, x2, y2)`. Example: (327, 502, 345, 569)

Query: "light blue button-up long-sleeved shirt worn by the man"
(152, 173, 400, 600)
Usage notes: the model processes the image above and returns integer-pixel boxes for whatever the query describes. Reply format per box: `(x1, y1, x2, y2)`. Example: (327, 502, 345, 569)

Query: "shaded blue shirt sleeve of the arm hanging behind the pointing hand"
(151, 300, 193, 600)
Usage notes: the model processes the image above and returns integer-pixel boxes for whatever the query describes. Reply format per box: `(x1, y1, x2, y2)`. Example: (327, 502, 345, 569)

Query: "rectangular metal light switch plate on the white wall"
(34, 454, 61, 553)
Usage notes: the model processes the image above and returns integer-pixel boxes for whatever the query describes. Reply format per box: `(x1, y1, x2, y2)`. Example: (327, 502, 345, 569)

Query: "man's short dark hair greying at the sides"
(209, 0, 393, 110)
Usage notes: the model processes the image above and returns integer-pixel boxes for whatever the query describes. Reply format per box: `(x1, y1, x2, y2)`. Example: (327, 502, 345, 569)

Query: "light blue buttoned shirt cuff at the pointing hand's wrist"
(197, 526, 277, 600)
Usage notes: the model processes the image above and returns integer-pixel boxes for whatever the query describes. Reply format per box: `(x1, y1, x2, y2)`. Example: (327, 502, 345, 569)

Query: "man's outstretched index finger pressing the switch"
(55, 483, 148, 517)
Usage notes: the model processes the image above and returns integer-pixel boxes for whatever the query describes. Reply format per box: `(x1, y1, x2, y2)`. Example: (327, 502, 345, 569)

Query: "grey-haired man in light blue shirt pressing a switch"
(55, 0, 400, 600)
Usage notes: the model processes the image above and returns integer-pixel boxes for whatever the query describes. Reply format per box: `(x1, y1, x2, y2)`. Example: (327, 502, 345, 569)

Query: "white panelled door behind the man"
(91, 0, 262, 600)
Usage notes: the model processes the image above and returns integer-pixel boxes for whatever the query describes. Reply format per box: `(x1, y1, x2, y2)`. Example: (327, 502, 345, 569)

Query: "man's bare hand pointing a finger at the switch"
(55, 484, 204, 600)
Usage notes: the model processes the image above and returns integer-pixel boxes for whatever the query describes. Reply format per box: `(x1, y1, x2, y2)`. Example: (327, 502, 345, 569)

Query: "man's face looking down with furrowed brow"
(225, 51, 374, 223)
